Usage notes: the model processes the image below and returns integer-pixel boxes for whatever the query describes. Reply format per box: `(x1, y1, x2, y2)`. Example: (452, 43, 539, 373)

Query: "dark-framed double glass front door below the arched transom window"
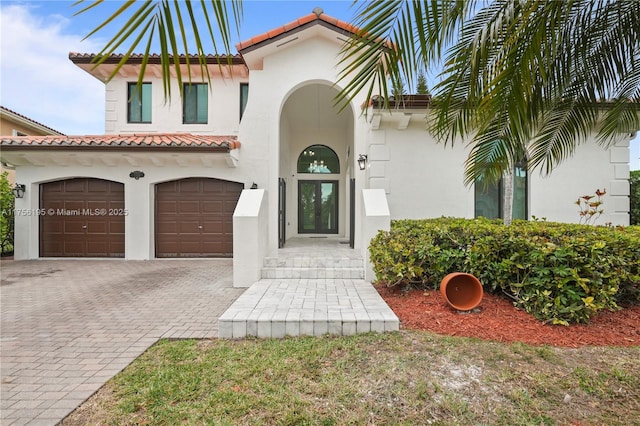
(298, 180, 338, 234)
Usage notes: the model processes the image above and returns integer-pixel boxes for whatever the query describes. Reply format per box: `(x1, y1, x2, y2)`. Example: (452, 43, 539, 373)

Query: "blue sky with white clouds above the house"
(0, 0, 640, 170)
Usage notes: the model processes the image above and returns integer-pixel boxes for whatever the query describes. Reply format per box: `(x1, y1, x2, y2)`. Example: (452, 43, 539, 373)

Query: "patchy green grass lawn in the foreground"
(62, 331, 640, 425)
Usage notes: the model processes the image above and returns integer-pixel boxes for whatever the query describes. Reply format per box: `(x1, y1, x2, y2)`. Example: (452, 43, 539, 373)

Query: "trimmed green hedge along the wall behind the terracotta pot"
(369, 218, 640, 324)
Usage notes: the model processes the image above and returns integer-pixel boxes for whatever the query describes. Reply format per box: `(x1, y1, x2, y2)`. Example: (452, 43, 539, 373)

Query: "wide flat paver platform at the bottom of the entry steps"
(218, 279, 400, 339)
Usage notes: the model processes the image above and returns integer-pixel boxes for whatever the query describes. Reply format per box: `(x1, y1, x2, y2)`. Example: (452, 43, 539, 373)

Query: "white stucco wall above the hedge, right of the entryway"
(367, 117, 629, 225)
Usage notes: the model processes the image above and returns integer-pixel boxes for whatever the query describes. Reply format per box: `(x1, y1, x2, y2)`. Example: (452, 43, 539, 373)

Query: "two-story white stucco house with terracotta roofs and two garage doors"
(2, 11, 629, 284)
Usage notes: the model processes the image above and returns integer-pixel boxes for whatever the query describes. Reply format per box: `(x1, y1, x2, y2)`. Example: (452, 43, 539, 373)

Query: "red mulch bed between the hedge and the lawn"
(376, 285, 640, 348)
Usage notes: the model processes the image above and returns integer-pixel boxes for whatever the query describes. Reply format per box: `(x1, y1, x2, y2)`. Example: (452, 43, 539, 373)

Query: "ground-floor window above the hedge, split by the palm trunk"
(475, 164, 528, 220)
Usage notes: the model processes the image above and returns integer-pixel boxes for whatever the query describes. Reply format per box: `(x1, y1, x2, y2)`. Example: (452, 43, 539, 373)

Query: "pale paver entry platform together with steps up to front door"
(218, 239, 400, 339)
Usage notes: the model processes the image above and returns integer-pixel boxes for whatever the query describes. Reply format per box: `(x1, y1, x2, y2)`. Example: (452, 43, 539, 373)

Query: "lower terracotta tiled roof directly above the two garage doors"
(0, 133, 240, 151)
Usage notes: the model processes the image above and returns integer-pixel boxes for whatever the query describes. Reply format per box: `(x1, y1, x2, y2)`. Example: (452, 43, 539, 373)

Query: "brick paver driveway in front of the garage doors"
(0, 259, 244, 425)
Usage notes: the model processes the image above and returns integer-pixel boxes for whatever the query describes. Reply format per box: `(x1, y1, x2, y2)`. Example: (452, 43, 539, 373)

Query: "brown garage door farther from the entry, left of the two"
(40, 178, 126, 257)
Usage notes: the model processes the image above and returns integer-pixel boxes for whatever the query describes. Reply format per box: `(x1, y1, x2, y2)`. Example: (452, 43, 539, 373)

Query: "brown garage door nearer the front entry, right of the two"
(156, 178, 244, 257)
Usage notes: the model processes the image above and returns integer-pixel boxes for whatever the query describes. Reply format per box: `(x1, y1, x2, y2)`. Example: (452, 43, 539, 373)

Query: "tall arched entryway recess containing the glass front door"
(279, 82, 354, 246)
